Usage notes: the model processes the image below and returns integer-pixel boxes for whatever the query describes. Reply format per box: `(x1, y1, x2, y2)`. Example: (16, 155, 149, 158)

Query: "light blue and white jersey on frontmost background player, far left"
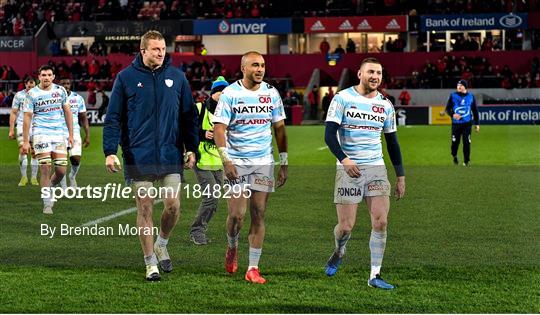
(23, 83, 67, 136)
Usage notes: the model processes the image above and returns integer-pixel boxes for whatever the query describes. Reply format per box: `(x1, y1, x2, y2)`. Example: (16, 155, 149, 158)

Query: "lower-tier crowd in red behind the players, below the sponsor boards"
(0, 54, 540, 107)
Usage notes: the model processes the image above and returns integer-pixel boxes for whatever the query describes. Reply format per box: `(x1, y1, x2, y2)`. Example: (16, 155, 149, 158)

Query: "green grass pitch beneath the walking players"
(0, 126, 540, 313)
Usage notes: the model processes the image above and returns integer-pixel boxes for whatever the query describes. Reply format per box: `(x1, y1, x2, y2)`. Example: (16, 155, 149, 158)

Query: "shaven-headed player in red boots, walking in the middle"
(213, 51, 288, 284)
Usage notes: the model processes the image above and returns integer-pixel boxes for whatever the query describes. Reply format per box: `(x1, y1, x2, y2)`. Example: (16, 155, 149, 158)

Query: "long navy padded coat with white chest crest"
(103, 54, 199, 180)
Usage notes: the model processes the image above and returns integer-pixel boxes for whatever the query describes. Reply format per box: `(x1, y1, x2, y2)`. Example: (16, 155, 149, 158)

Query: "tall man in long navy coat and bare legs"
(103, 31, 199, 281)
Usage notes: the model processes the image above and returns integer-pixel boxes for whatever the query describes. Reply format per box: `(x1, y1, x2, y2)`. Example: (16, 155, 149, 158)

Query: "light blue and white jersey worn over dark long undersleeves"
(326, 86, 397, 165)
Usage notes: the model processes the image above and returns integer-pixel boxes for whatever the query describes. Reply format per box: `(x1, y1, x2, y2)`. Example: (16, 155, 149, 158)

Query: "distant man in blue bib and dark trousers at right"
(446, 79, 480, 166)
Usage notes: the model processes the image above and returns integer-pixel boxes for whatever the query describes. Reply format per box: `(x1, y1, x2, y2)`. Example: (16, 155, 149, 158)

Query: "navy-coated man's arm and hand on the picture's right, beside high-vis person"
(180, 74, 199, 168)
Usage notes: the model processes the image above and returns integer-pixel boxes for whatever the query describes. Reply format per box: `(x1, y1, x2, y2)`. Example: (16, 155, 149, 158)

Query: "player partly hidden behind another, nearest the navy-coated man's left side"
(60, 78, 90, 187)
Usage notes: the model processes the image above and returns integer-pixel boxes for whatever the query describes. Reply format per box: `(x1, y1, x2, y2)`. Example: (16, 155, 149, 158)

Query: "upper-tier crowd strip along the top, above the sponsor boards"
(0, 0, 540, 36)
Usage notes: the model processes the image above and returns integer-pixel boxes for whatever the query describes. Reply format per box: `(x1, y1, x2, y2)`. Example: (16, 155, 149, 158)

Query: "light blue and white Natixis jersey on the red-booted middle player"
(213, 80, 285, 159)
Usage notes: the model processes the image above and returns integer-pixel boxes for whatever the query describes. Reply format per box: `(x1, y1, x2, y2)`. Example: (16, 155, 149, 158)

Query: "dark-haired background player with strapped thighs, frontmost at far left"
(22, 65, 73, 214)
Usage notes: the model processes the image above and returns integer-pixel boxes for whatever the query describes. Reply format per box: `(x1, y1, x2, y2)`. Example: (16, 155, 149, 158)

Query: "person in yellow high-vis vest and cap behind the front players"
(190, 76, 229, 245)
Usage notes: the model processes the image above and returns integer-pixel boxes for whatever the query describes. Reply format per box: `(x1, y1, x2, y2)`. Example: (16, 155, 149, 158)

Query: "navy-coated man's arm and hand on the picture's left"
(103, 76, 127, 172)
